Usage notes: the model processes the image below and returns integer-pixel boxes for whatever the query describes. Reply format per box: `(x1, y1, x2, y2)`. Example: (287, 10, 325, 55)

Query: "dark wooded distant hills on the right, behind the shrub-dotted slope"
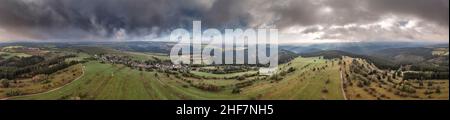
(300, 47, 449, 72)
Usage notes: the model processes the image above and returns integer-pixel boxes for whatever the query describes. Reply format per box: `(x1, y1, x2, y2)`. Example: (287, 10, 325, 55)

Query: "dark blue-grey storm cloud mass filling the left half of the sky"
(0, 0, 250, 38)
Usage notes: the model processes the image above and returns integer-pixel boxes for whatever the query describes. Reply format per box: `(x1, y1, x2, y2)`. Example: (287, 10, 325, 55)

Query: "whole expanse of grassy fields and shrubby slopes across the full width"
(0, 43, 449, 100)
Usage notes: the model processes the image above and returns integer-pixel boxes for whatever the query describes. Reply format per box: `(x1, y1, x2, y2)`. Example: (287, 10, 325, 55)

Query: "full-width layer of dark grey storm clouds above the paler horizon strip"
(0, 0, 449, 39)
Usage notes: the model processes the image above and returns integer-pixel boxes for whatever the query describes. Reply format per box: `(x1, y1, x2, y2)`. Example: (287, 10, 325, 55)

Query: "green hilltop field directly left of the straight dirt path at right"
(243, 57, 343, 100)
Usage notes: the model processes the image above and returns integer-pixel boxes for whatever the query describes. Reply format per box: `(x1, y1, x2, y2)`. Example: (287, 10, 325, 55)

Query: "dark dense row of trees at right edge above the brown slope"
(403, 72, 448, 80)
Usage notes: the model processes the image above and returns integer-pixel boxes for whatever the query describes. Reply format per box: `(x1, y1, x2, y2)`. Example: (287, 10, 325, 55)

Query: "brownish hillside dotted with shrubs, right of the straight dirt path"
(343, 57, 449, 100)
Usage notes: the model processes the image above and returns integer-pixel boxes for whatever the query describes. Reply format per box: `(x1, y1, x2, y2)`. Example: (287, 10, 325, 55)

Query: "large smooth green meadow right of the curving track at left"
(15, 62, 250, 99)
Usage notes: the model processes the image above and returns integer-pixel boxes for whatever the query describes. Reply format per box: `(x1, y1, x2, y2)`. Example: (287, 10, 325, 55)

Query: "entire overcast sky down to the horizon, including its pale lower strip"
(0, 0, 449, 43)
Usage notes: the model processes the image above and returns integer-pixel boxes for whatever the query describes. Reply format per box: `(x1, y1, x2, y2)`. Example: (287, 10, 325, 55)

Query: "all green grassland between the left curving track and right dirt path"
(14, 58, 343, 99)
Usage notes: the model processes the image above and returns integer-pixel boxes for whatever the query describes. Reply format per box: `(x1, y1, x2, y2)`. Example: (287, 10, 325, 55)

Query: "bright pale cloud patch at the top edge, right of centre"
(271, 0, 380, 28)
